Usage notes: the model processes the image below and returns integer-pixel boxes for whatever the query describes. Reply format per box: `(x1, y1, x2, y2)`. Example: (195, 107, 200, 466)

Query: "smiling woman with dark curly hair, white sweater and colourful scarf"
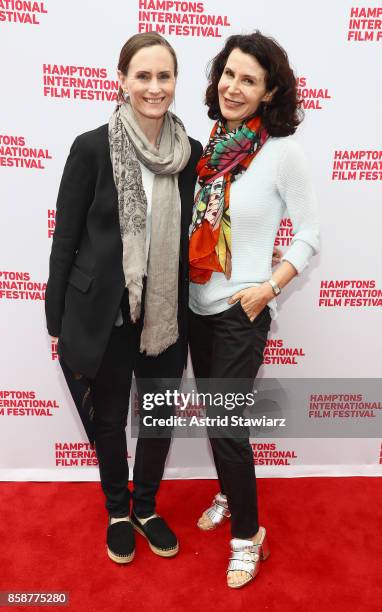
(190, 31, 319, 588)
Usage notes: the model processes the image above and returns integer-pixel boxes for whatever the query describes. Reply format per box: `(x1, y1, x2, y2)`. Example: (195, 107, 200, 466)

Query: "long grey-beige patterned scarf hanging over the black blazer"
(109, 103, 191, 356)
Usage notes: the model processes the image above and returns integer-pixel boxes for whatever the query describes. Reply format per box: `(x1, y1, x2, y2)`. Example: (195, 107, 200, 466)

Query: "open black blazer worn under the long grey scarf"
(45, 125, 202, 378)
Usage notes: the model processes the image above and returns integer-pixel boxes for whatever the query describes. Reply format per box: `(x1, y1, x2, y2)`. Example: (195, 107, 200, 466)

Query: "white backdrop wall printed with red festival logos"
(0, 0, 382, 480)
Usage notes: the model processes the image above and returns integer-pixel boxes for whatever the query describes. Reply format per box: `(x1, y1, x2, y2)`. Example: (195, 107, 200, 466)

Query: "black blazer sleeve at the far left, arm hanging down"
(45, 136, 95, 336)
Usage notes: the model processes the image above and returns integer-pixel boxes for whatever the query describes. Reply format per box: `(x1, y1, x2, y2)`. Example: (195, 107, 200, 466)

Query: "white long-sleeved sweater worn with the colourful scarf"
(190, 136, 319, 318)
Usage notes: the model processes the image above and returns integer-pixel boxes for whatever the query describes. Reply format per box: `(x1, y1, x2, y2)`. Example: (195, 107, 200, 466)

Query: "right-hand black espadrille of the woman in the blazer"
(131, 512, 179, 557)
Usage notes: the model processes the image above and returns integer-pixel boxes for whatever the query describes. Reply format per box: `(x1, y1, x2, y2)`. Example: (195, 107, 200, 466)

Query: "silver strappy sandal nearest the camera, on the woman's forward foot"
(227, 527, 270, 589)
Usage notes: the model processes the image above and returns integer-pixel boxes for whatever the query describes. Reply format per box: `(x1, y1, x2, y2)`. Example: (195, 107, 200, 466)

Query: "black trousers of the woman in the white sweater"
(189, 302, 271, 539)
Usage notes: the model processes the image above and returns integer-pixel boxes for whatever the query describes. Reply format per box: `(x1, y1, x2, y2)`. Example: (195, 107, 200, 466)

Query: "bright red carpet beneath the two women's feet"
(0, 478, 382, 612)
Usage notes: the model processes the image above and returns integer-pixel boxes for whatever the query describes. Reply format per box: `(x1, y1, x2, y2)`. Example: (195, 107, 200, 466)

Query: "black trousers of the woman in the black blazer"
(90, 291, 183, 518)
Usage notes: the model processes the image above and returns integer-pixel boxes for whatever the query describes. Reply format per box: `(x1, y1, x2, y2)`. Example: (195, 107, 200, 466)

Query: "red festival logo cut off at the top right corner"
(347, 6, 382, 43)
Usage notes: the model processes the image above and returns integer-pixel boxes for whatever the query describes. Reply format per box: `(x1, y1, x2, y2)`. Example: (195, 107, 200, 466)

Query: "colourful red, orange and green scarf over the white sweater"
(190, 117, 268, 285)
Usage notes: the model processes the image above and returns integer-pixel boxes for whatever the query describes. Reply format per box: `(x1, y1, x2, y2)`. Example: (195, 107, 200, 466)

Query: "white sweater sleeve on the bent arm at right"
(277, 139, 319, 274)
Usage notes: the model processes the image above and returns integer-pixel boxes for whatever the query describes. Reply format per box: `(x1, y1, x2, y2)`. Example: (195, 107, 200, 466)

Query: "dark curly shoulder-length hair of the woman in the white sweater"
(205, 30, 304, 136)
